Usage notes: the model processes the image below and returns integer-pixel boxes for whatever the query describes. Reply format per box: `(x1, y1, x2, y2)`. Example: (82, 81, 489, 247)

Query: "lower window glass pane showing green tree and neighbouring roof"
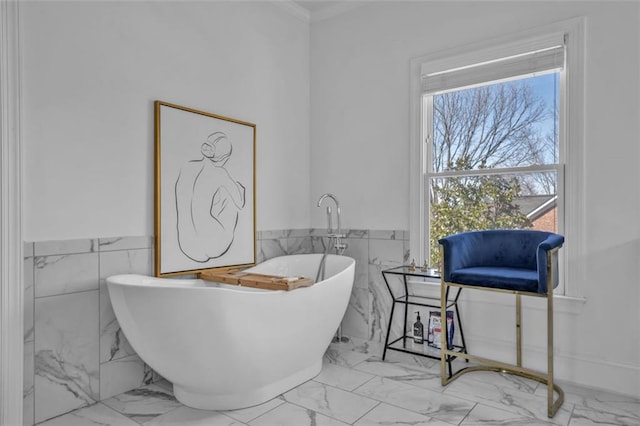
(427, 172, 558, 265)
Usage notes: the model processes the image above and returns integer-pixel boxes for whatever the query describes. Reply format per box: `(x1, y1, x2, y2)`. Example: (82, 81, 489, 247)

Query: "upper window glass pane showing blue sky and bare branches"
(430, 72, 559, 173)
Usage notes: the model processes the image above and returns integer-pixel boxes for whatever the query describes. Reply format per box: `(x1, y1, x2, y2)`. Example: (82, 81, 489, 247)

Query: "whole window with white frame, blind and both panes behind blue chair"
(411, 22, 581, 294)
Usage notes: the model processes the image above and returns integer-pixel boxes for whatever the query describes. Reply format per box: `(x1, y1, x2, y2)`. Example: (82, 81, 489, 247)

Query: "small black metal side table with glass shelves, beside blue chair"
(382, 266, 468, 376)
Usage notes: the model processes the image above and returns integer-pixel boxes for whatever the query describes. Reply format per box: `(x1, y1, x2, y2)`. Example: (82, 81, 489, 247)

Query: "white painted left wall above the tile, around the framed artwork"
(21, 1, 310, 241)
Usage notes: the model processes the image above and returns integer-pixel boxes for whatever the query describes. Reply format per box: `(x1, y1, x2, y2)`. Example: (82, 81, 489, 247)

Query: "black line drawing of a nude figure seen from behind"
(175, 132, 246, 263)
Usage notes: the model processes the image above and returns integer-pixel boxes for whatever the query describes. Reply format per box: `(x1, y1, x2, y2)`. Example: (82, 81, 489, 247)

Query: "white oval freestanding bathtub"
(107, 254, 355, 410)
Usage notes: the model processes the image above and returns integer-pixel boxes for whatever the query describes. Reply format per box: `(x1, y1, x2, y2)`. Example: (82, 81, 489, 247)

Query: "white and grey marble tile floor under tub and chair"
(40, 343, 640, 426)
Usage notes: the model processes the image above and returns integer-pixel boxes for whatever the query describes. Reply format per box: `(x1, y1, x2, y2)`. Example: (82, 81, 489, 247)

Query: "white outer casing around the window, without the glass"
(409, 18, 585, 297)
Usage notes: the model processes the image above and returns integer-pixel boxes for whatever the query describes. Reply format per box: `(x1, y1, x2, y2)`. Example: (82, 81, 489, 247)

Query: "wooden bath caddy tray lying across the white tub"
(200, 269, 314, 291)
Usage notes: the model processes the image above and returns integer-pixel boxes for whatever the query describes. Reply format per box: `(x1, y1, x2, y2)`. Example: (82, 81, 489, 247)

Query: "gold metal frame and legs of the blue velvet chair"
(440, 246, 564, 418)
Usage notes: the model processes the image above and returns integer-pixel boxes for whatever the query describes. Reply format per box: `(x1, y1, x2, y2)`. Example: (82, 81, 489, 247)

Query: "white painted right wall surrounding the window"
(311, 1, 640, 395)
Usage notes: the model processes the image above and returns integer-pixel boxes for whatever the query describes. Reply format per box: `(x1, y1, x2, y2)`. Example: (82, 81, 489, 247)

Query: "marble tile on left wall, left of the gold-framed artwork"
(24, 237, 153, 425)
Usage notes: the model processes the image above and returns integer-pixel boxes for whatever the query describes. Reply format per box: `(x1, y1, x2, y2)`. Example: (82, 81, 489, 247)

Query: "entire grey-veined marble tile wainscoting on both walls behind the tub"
(24, 229, 408, 425)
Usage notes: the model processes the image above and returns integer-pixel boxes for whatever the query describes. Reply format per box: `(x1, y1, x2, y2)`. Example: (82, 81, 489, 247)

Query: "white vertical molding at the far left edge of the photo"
(0, 0, 24, 425)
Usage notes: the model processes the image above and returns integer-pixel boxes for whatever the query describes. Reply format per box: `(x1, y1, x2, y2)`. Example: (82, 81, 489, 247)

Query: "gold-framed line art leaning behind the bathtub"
(155, 101, 256, 277)
